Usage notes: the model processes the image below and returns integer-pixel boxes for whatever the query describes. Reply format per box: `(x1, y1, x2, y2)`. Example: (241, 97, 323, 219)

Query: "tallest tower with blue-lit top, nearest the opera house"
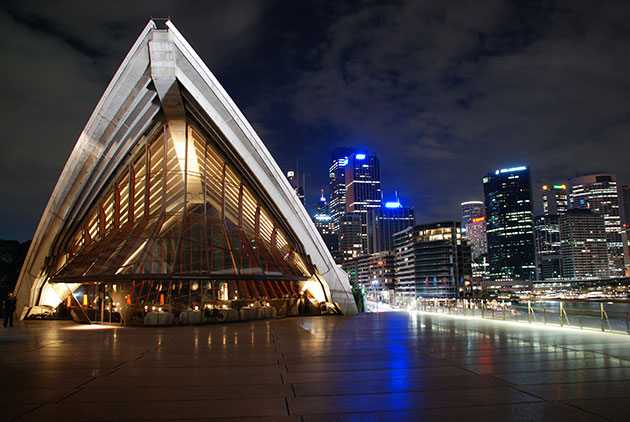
(345, 153, 381, 253)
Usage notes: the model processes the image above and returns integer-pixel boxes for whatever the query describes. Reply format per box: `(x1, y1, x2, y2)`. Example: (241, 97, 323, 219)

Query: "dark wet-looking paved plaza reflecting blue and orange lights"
(0, 313, 630, 421)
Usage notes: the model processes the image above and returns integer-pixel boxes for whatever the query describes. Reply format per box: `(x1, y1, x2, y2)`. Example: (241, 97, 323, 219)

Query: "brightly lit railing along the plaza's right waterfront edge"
(411, 299, 630, 334)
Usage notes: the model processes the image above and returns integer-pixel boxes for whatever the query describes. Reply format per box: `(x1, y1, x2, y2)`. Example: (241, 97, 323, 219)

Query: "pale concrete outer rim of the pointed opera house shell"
(16, 21, 357, 314)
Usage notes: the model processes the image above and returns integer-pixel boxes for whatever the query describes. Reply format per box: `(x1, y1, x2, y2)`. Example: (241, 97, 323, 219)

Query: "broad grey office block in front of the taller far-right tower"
(558, 208, 610, 280)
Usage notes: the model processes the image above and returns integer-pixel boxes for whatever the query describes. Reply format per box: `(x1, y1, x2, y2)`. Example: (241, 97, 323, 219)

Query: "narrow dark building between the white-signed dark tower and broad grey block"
(535, 211, 566, 280)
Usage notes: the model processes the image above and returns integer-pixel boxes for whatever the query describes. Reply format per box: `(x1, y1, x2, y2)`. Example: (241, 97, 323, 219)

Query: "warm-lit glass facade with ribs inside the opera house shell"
(48, 121, 313, 320)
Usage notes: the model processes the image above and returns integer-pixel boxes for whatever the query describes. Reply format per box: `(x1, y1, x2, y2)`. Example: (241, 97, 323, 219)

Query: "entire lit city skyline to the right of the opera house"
(288, 153, 630, 303)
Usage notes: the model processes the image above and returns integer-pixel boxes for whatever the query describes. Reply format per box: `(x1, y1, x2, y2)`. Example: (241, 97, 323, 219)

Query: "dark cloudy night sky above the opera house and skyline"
(0, 0, 630, 240)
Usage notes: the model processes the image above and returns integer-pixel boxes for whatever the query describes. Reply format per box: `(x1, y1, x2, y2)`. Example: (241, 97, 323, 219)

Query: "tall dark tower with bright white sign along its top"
(483, 166, 536, 281)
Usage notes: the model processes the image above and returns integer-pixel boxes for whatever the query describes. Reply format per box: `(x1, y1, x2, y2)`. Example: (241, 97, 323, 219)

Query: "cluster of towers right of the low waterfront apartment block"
(461, 166, 630, 294)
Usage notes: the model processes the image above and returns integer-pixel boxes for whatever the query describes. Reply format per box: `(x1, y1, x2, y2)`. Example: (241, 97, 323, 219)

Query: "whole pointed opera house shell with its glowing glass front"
(16, 21, 356, 322)
